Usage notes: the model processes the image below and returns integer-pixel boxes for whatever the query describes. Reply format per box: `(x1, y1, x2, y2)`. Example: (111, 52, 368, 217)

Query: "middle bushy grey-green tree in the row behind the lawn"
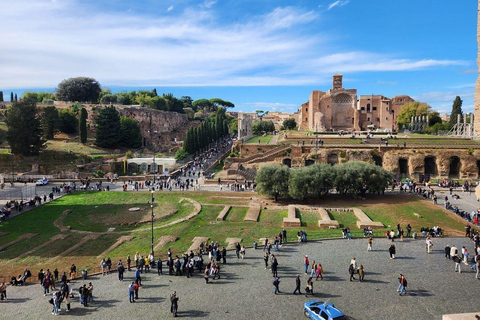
(288, 163, 336, 200)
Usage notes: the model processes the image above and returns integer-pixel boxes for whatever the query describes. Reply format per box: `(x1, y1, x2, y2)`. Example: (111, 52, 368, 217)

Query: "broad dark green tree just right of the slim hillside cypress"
(95, 106, 121, 148)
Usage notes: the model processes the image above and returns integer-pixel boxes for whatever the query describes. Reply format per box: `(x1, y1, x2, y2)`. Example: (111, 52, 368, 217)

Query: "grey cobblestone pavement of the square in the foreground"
(0, 238, 480, 320)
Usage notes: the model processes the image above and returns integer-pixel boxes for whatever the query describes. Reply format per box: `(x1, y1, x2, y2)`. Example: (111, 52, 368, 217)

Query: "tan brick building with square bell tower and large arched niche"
(296, 74, 414, 132)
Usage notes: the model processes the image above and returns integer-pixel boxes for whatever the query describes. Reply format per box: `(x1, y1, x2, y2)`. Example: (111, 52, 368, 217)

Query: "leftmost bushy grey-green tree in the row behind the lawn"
(257, 165, 290, 201)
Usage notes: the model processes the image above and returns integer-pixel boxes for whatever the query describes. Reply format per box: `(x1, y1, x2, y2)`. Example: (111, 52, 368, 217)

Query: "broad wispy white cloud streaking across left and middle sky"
(0, 0, 466, 88)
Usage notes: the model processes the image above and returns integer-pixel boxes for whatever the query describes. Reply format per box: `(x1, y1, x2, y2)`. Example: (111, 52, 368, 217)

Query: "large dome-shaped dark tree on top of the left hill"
(56, 77, 102, 103)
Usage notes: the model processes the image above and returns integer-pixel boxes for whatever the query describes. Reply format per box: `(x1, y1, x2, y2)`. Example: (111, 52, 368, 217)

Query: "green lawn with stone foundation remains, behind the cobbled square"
(0, 192, 465, 276)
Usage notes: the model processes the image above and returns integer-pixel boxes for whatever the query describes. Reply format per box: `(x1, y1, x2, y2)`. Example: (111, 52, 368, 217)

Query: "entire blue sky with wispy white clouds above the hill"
(0, 0, 478, 113)
